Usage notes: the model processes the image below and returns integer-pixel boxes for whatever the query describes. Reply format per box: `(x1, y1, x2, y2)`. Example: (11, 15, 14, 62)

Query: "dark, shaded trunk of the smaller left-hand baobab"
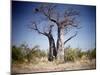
(48, 34, 57, 61)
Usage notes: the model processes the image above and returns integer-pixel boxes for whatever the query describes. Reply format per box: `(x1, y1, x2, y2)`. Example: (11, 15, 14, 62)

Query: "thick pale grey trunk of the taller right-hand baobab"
(57, 27, 64, 62)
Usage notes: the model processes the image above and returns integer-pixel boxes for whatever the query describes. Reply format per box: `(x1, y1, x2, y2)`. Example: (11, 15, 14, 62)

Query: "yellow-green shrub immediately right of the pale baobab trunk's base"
(64, 48, 86, 62)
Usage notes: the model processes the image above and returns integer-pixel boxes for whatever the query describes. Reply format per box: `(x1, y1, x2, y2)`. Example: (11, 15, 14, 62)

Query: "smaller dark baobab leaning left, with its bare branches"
(29, 21, 57, 61)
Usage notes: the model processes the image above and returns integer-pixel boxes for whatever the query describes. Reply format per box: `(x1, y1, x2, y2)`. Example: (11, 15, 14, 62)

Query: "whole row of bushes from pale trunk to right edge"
(64, 48, 96, 62)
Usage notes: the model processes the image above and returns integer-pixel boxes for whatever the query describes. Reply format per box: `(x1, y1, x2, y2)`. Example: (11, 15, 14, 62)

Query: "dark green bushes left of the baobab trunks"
(12, 44, 47, 62)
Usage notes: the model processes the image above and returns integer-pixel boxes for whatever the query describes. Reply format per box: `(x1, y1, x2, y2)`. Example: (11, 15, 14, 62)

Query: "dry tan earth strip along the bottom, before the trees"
(12, 59, 96, 73)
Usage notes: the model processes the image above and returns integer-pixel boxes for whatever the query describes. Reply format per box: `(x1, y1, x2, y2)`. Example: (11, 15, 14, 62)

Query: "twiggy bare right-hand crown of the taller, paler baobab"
(59, 8, 79, 27)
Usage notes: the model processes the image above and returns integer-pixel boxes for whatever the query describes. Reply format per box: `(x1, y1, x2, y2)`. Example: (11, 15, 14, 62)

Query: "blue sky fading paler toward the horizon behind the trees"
(12, 1, 96, 50)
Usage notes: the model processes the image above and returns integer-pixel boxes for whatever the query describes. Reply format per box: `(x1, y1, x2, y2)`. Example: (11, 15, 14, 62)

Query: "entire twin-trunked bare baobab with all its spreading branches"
(29, 4, 79, 61)
